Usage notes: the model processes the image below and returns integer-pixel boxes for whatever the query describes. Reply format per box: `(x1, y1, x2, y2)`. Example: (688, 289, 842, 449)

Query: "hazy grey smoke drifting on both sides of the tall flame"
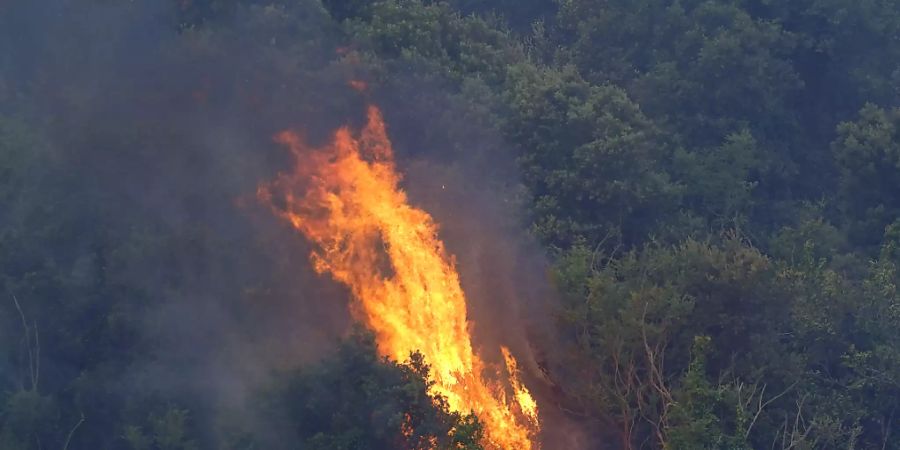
(0, 0, 571, 448)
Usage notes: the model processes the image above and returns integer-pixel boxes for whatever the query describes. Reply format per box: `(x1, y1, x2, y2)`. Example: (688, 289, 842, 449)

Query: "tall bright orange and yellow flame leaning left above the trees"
(258, 106, 538, 450)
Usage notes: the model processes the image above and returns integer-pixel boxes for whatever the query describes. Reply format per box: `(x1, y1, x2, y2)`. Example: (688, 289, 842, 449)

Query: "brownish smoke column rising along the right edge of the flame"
(376, 75, 601, 450)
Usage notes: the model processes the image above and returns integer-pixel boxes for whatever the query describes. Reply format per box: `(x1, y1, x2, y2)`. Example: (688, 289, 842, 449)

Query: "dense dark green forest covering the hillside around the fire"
(0, 0, 900, 450)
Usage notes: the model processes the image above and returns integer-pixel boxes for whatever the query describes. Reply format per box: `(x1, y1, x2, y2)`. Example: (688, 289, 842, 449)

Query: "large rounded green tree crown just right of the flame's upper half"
(505, 64, 679, 248)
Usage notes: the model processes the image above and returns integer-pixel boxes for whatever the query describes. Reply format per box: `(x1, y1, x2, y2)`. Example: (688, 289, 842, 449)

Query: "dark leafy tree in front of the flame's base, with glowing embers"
(256, 331, 482, 450)
